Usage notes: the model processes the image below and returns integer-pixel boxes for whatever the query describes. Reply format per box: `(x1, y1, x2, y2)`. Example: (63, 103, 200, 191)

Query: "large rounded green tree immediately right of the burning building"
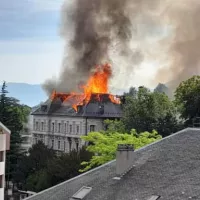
(122, 87, 179, 137)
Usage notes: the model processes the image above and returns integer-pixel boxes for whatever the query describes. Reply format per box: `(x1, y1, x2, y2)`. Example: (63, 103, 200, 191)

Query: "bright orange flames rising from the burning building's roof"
(51, 64, 120, 111)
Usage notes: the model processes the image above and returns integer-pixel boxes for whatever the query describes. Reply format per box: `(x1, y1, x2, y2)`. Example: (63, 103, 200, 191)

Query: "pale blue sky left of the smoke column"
(0, 0, 64, 83)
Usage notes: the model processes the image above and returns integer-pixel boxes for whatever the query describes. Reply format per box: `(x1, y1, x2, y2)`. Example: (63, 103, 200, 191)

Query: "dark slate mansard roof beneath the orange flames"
(32, 95, 123, 118)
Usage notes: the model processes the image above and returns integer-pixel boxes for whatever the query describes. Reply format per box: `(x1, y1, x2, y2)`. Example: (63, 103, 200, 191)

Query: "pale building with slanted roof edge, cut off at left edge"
(0, 122, 11, 200)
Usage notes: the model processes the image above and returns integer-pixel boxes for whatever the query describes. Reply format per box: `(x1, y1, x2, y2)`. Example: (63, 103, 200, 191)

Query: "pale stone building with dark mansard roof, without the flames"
(32, 95, 122, 152)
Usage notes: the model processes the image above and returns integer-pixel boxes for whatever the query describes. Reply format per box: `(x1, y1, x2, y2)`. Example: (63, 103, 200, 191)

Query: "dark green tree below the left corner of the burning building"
(13, 141, 56, 192)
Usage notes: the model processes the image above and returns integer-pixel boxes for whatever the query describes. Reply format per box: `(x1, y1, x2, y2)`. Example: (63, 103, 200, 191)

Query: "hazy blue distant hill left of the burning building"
(6, 83, 47, 107)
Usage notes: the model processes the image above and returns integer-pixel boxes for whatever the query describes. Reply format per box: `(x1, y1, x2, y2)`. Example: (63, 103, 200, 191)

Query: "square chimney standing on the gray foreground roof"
(116, 144, 134, 176)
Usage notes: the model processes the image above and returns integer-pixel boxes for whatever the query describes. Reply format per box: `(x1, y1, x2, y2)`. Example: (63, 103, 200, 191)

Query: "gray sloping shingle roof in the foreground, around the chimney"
(25, 128, 200, 200)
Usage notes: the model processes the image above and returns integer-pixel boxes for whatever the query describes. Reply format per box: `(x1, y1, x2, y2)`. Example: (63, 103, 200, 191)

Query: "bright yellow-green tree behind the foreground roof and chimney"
(80, 129, 162, 172)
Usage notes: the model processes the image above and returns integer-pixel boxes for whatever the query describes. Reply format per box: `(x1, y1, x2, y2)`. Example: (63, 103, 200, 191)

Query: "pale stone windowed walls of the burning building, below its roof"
(32, 115, 104, 152)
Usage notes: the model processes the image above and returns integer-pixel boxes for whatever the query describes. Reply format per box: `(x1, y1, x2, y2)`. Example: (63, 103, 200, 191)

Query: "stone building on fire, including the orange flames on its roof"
(32, 64, 122, 152)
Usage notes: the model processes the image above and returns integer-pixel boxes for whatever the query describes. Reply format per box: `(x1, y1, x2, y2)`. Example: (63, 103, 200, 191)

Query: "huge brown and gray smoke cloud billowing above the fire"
(43, 0, 200, 92)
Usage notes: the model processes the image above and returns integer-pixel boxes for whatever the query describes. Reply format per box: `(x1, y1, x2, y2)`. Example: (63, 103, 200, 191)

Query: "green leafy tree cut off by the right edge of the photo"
(175, 76, 200, 125)
